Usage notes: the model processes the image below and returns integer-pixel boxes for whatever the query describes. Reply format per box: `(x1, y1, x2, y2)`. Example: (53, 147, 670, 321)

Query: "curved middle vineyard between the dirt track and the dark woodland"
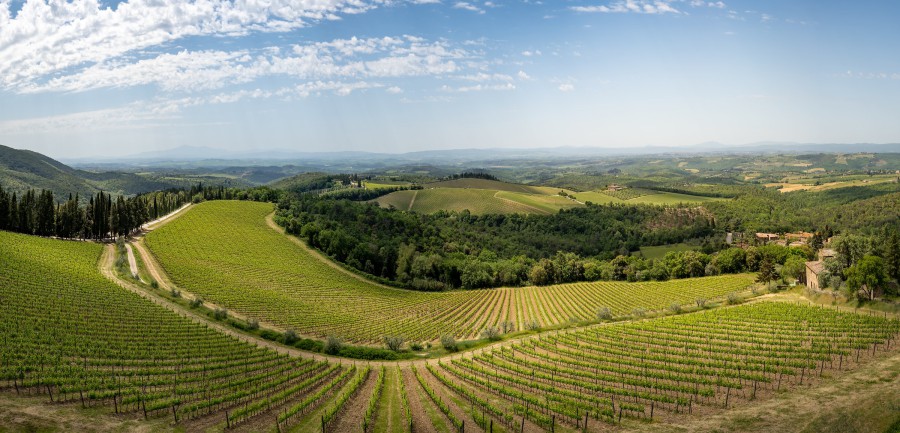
(145, 201, 753, 343)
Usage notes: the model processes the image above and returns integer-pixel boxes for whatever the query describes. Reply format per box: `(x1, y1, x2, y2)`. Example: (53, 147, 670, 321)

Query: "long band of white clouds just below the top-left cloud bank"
(18, 36, 476, 93)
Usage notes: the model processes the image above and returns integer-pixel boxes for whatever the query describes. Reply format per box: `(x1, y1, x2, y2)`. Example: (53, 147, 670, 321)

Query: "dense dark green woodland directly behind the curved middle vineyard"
(276, 195, 715, 290)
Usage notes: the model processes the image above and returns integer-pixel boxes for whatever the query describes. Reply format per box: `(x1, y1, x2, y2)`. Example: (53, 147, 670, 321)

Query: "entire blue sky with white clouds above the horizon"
(0, 0, 900, 157)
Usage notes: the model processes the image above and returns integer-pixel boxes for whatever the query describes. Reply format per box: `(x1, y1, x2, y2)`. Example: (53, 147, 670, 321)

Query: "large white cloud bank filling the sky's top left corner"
(0, 0, 382, 89)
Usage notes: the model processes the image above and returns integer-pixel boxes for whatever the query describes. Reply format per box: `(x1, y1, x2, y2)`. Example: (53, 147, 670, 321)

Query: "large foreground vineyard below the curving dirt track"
(0, 226, 900, 433)
